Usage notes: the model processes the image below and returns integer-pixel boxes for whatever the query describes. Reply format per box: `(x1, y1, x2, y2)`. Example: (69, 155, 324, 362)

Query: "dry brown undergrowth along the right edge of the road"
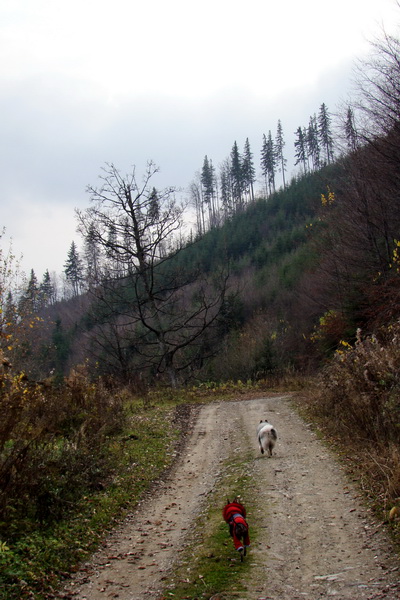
(301, 322, 400, 524)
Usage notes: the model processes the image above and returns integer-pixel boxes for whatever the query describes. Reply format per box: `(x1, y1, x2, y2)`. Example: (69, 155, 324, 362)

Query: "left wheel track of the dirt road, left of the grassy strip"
(59, 404, 233, 600)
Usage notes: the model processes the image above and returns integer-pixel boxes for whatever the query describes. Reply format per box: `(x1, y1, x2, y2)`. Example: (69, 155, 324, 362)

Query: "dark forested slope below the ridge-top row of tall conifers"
(3, 142, 398, 385)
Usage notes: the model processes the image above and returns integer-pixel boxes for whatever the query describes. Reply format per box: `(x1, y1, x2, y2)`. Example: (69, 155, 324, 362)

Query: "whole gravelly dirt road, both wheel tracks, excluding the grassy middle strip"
(60, 396, 400, 600)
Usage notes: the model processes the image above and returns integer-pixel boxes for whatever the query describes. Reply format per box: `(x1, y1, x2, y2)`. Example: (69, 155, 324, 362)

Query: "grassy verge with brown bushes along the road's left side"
(0, 354, 272, 600)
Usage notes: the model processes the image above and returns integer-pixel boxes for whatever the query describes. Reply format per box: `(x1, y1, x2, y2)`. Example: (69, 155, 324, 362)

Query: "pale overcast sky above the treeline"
(0, 0, 400, 280)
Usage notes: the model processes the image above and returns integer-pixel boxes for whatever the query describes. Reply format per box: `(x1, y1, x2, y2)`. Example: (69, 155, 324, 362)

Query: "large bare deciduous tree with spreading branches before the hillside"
(77, 162, 227, 386)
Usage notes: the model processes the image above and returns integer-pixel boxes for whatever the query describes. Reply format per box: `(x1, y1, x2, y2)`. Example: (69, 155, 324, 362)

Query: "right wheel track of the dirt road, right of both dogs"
(239, 398, 399, 600)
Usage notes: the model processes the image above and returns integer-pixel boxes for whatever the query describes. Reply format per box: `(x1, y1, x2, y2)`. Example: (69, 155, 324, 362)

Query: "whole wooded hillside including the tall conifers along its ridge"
(2, 22, 400, 386)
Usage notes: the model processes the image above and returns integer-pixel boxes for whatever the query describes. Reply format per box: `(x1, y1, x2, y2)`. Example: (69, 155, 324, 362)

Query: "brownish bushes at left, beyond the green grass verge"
(0, 356, 124, 540)
